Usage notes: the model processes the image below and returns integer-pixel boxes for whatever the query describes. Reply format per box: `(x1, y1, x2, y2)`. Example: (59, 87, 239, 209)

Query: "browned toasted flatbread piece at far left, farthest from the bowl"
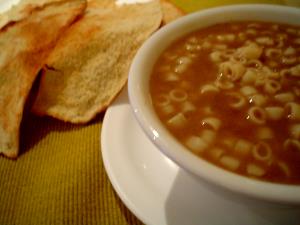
(0, 0, 86, 158)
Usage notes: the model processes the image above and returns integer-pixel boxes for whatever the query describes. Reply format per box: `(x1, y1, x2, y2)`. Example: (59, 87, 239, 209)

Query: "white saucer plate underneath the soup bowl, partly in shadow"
(101, 87, 300, 225)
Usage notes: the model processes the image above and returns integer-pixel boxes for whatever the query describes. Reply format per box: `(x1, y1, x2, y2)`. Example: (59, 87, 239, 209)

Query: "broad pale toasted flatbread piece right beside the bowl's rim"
(32, 0, 162, 123)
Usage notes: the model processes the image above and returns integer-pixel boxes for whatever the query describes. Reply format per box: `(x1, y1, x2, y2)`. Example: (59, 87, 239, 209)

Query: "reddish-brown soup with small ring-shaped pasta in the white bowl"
(150, 22, 300, 184)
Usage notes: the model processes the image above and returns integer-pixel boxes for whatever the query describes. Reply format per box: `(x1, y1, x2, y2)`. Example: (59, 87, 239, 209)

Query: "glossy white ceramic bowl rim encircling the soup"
(128, 5, 300, 205)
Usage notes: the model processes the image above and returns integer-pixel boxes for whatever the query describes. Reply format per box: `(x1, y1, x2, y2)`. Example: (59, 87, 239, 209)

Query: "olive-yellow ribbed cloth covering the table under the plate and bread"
(0, 0, 299, 225)
